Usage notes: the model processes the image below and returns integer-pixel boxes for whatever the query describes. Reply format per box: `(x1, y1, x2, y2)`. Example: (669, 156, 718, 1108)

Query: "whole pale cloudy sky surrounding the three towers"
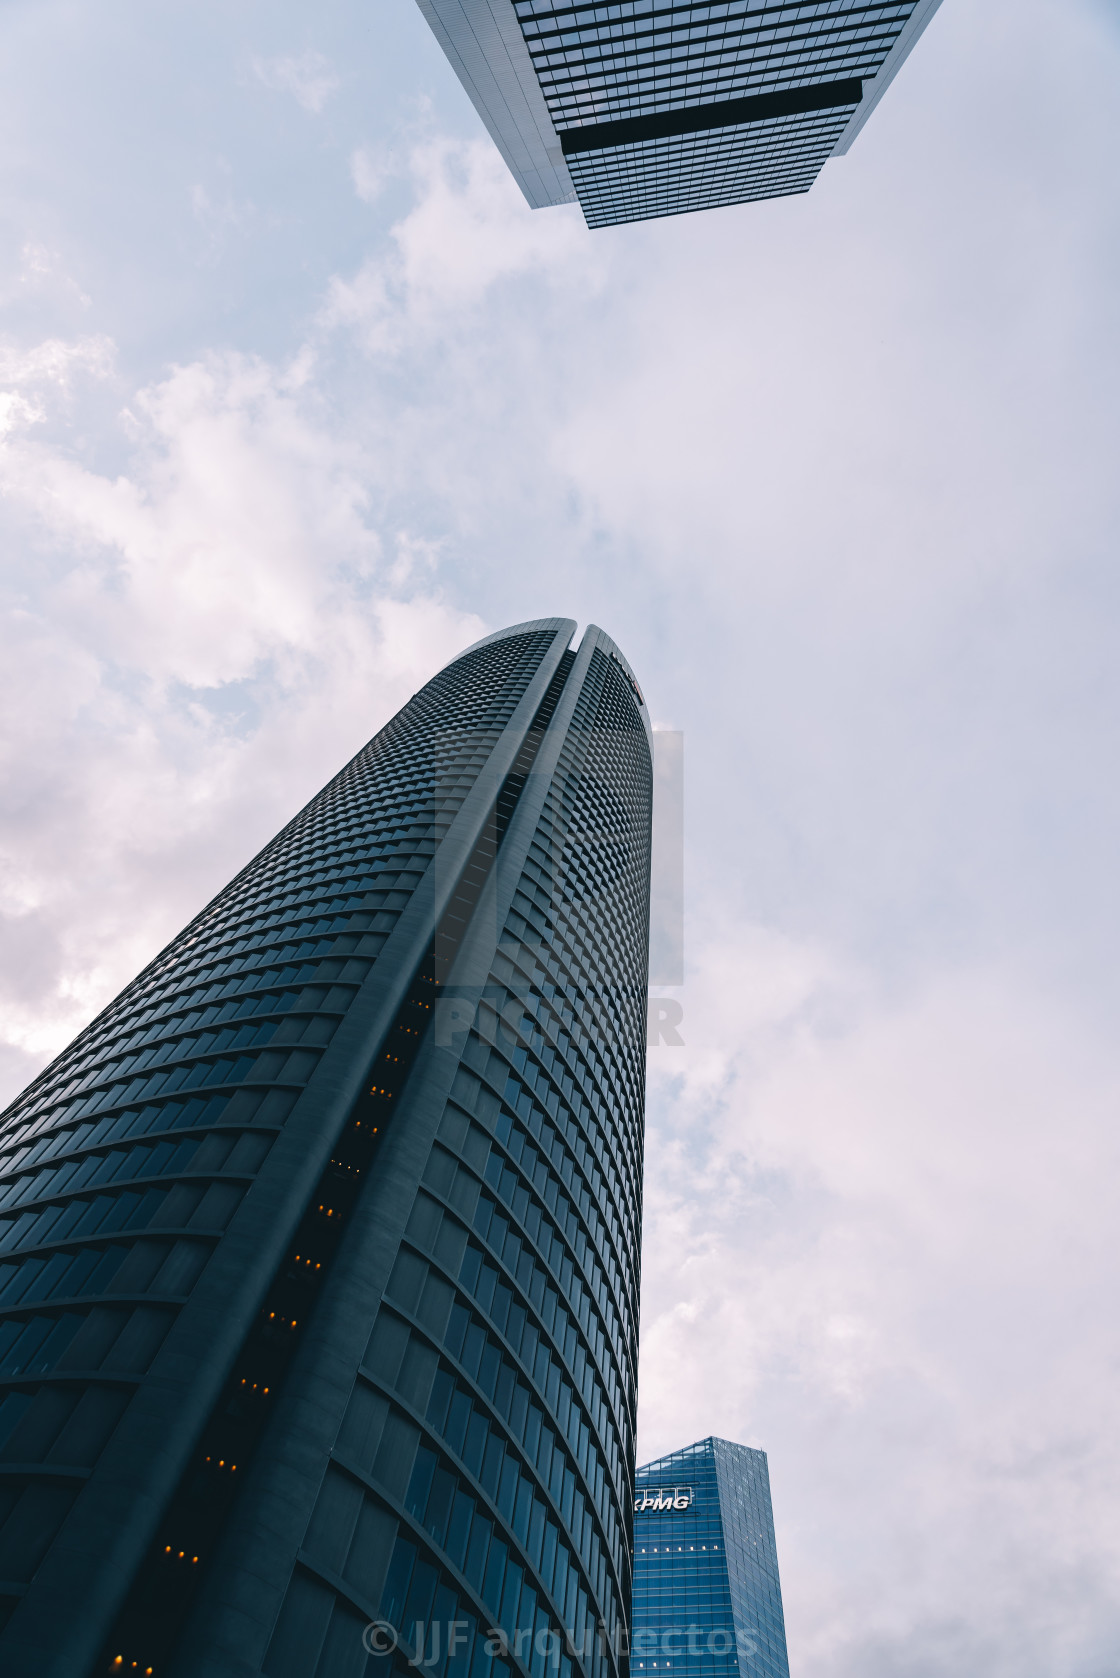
(0, 0, 1120, 1678)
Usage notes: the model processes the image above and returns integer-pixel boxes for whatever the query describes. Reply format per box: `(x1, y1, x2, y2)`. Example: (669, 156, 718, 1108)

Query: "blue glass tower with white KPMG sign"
(630, 1438, 789, 1678)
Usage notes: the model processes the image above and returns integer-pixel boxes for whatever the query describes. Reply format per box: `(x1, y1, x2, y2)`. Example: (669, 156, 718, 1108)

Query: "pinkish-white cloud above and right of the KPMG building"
(640, 928, 1120, 1678)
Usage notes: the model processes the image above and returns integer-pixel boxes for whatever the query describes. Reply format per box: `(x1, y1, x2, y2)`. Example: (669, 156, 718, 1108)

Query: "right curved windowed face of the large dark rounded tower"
(255, 631, 652, 1678)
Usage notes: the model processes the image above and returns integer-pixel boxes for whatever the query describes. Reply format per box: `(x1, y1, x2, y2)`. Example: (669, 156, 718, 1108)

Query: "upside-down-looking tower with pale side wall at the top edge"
(418, 0, 940, 228)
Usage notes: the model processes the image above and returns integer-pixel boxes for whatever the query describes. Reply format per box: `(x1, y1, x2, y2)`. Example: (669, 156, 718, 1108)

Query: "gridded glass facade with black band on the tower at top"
(514, 0, 917, 227)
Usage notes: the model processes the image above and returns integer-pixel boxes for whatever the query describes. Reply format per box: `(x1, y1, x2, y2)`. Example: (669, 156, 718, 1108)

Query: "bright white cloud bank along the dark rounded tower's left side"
(0, 330, 484, 1079)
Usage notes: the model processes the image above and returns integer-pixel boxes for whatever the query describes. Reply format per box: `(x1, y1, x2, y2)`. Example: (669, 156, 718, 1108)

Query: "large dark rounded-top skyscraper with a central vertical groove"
(0, 619, 652, 1678)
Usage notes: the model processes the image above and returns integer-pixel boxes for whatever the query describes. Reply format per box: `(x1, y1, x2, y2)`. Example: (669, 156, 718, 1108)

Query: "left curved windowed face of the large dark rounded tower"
(0, 626, 556, 1651)
